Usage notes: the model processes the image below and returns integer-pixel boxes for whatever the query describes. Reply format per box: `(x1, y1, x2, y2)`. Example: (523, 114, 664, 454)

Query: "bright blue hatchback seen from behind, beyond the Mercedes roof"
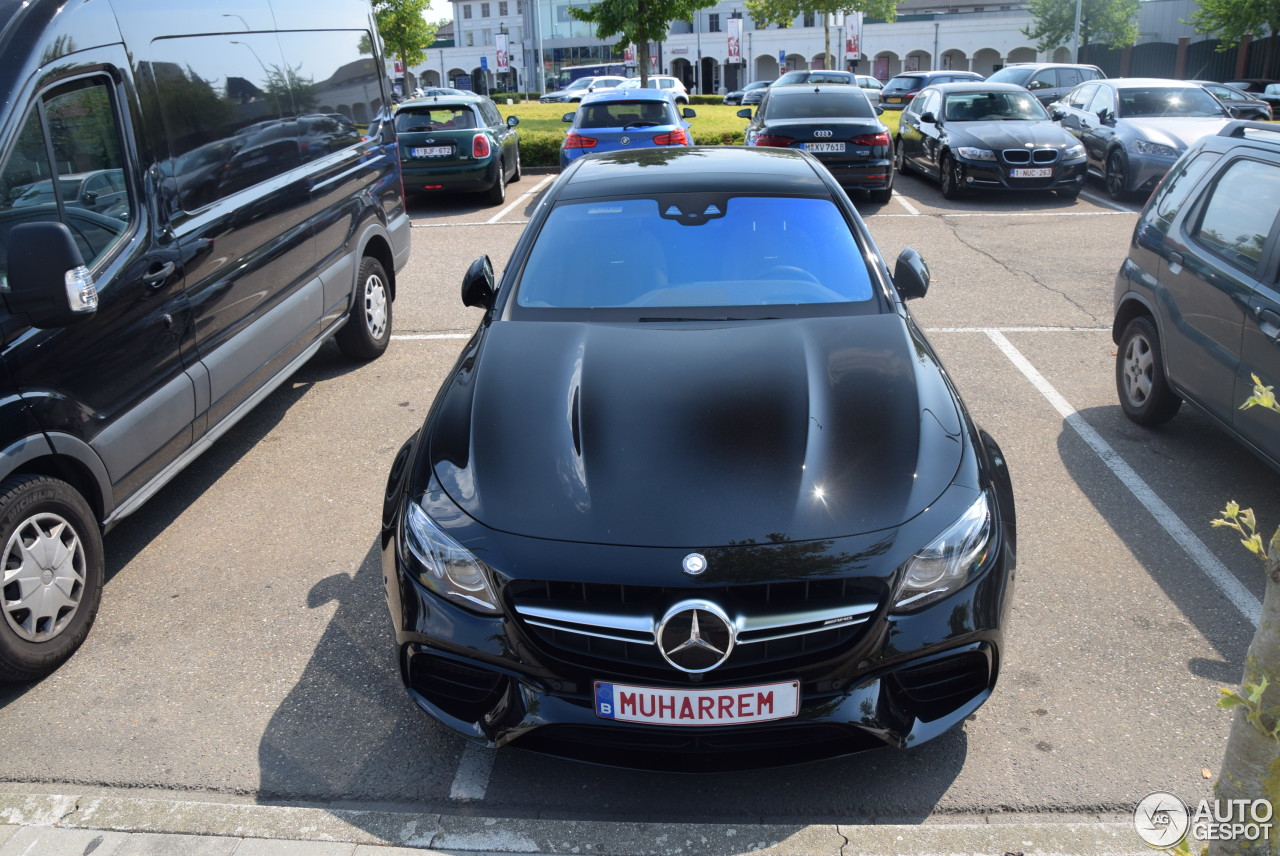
(561, 90, 698, 169)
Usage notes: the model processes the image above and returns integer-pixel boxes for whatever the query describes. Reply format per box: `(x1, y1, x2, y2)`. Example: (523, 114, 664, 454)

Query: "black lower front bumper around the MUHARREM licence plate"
(383, 522, 1012, 772)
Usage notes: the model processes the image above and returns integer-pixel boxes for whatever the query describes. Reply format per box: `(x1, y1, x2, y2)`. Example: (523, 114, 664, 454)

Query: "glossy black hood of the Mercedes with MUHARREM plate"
(429, 315, 968, 546)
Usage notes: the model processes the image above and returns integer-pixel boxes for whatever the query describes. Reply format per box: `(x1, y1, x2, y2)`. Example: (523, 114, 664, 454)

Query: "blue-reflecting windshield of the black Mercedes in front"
(515, 193, 877, 317)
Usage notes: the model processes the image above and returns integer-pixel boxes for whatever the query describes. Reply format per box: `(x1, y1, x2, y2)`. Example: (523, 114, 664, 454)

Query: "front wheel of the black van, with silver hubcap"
(0, 476, 102, 681)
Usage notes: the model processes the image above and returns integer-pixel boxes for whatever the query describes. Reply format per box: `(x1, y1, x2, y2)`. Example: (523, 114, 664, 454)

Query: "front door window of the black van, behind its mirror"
(0, 78, 136, 290)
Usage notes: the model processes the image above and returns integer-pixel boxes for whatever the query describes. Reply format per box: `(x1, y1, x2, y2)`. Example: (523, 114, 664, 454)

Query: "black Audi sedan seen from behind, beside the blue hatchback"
(737, 83, 893, 202)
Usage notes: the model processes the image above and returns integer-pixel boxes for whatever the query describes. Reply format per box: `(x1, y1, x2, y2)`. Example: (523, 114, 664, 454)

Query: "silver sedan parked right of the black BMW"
(1051, 77, 1231, 200)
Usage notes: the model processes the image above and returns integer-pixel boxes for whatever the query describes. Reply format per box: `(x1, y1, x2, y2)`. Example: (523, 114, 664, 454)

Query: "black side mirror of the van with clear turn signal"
(5, 220, 97, 330)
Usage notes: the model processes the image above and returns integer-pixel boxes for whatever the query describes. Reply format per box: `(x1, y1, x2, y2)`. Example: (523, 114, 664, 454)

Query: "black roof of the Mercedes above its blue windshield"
(558, 146, 831, 200)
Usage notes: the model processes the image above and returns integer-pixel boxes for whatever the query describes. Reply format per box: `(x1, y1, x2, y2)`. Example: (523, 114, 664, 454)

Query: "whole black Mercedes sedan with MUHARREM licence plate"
(381, 146, 1015, 772)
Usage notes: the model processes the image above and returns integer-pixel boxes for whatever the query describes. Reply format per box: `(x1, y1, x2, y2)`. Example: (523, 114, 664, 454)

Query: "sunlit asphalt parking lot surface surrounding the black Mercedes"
(0, 166, 1280, 827)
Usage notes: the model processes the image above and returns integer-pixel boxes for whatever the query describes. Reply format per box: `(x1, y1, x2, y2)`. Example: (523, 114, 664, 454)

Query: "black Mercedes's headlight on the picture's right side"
(893, 493, 992, 612)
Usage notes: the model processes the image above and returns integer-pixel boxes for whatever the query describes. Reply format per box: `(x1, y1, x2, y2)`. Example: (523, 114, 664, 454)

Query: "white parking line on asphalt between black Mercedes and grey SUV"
(986, 330, 1262, 626)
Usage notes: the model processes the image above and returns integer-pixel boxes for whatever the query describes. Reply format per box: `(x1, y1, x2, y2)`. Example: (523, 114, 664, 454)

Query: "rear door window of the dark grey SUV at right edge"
(1194, 160, 1280, 273)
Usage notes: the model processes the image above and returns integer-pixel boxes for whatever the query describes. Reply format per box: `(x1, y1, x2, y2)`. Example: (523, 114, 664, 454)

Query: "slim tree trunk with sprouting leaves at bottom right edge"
(1210, 381, 1280, 856)
